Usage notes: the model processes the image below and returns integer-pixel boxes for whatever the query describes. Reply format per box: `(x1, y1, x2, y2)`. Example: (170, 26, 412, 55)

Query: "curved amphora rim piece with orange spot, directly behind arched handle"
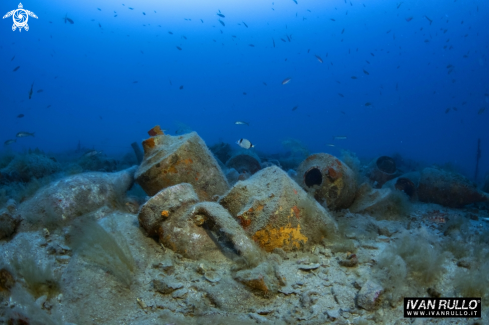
(138, 183, 199, 237)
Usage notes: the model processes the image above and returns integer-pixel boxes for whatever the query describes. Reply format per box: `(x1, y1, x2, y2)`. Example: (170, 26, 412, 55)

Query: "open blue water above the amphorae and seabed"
(0, 0, 489, 178)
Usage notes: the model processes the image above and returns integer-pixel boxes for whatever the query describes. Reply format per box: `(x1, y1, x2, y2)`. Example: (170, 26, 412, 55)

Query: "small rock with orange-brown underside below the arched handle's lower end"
(234, 262, 279, 297)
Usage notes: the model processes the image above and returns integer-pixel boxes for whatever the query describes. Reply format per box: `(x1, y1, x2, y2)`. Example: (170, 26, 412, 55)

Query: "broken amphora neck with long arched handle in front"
(159, 202, 262, 266)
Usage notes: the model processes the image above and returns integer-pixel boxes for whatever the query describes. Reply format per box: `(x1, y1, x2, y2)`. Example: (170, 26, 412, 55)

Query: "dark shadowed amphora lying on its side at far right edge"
(418, 168, 489, 208)
